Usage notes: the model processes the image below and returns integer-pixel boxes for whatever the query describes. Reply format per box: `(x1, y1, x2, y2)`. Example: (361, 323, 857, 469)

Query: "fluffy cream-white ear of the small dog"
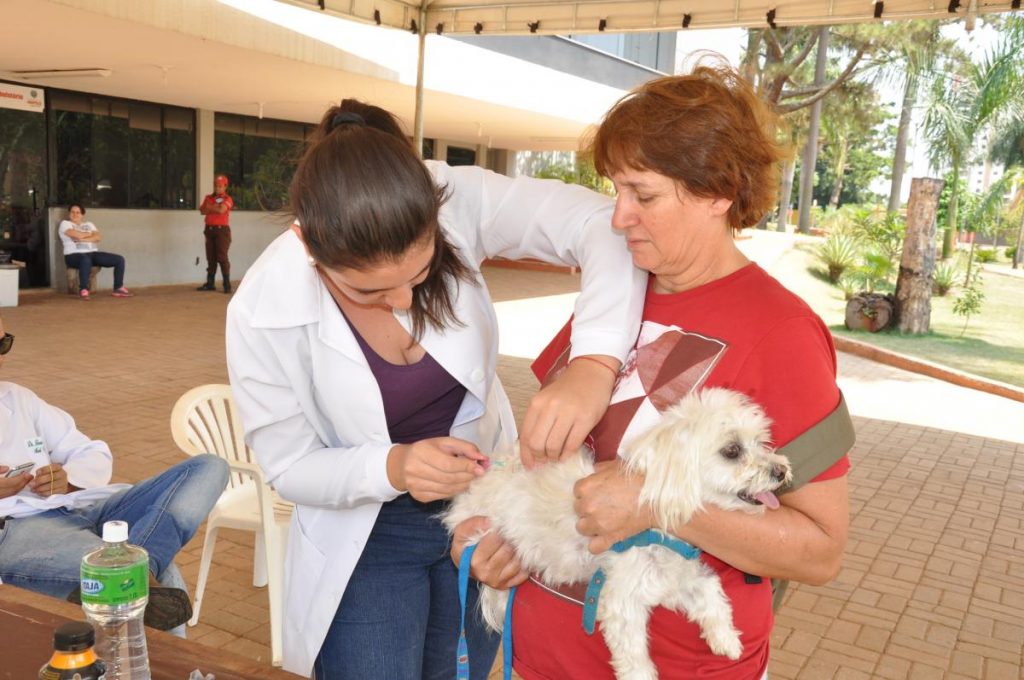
(626, 410, 702, 529)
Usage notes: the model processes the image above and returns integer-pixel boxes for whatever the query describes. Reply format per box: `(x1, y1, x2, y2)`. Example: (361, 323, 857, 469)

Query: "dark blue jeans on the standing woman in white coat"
(313, 494, 500, 680)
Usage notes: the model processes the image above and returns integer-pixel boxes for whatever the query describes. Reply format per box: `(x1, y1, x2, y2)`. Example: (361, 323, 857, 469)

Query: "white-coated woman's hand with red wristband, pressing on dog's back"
(519, 354, 618, 468)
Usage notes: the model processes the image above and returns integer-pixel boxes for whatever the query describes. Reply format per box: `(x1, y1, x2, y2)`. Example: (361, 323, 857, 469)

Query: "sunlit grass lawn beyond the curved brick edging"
(771, 241, 1024, 387)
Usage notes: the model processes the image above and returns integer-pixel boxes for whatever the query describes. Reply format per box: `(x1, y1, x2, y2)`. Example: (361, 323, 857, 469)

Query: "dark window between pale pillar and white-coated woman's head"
(213, 114, 316, 210)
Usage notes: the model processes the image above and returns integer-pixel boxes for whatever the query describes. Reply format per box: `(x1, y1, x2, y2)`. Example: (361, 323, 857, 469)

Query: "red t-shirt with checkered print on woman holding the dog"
(512, 264, 850, 680)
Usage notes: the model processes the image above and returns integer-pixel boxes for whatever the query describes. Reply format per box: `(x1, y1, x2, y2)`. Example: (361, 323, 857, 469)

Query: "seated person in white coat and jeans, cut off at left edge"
(0, 311, 227, 636)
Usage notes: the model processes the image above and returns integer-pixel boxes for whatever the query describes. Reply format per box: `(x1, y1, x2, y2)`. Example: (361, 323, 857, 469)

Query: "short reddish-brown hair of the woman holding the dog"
(589, 65, 788, 229)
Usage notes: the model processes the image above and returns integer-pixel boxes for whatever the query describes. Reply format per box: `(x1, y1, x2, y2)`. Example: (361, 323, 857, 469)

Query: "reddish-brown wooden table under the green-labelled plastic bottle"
(0, 585, 300, 680)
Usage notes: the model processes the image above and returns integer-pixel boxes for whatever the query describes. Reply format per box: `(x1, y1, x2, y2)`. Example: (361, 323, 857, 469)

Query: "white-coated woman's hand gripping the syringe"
(387, 437, 487, 503)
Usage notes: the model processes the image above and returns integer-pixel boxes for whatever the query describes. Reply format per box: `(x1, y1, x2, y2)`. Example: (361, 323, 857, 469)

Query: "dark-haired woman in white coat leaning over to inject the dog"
(227, 99, 644, 680)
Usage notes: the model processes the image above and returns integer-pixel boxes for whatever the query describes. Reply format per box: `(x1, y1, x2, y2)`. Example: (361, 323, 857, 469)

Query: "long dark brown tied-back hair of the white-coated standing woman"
(288, 99, 476, 338)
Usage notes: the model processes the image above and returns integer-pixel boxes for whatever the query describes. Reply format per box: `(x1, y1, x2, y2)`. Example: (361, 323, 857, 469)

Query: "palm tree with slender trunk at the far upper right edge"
(925, 17, 1024, 259)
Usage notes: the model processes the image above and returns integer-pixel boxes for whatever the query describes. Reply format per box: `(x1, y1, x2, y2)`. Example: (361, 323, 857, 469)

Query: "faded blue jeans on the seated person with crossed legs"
(0, 454, 227, 598)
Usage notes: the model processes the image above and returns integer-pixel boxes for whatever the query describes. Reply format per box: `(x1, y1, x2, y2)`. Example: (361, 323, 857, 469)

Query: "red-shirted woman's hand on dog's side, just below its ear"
(572, 460, 654, 555)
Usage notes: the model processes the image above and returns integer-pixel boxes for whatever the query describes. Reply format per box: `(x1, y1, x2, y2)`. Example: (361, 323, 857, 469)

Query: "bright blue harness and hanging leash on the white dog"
(456, 528, 700, 680)
